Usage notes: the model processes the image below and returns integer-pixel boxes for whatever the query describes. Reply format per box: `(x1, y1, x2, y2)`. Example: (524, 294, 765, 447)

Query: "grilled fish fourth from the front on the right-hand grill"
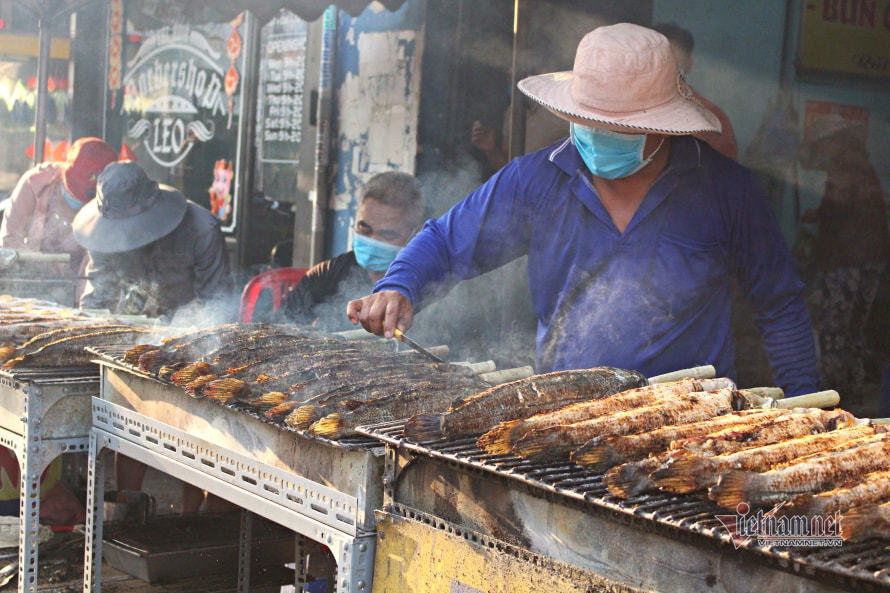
(652, 426, 875, 494)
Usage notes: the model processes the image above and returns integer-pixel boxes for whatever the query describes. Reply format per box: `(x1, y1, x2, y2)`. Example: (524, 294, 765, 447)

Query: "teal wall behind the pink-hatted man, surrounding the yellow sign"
(653, 0, 890, 242)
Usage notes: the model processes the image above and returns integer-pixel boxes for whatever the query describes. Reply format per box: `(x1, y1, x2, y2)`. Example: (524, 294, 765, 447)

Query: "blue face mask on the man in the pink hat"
(571, 123, 664, 179)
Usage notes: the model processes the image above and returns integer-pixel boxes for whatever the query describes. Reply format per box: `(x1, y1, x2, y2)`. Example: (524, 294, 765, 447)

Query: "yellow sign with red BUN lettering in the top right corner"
(799, 0, 890, 78)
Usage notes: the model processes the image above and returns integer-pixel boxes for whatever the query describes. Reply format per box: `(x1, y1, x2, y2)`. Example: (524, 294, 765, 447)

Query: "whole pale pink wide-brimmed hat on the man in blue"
(519, 23, 721, 135)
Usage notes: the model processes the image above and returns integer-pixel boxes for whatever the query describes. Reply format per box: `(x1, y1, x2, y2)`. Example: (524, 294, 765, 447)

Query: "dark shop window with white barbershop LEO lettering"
(120, 16, 246, 232)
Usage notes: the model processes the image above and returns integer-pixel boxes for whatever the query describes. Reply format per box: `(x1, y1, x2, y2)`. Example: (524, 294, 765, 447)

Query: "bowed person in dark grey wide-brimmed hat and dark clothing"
(73, 162, 231, 316)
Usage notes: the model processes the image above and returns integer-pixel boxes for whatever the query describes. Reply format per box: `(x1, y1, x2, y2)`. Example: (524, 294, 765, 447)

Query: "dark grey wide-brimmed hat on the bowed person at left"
(72, 162, 186, 253)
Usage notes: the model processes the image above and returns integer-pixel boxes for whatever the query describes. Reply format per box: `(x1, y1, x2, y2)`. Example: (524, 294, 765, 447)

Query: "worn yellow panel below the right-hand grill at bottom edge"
(373, 511, 639, 593)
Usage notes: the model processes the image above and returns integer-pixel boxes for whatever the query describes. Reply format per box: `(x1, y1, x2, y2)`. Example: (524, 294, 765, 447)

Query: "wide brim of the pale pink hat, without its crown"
(518, 71, 722, 136)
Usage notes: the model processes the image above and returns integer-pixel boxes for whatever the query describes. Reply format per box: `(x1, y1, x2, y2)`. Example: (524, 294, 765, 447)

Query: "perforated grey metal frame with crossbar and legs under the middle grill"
(84, 398, 375, 593)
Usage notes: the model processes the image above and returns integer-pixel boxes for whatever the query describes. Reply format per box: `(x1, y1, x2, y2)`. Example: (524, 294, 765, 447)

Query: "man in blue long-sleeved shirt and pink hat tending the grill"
(347, 23, 818, 395)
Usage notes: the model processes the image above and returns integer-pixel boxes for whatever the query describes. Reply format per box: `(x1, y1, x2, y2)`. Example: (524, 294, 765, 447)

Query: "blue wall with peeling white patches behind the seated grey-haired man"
(326, 0, 423, 257)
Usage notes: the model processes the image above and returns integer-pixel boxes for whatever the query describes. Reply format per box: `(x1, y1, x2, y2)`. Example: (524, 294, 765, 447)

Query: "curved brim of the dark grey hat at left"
(72, 185, 187, 253)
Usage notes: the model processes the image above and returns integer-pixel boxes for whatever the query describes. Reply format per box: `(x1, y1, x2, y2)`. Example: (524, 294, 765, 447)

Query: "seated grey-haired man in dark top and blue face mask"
(282, 171, 425, 331)
